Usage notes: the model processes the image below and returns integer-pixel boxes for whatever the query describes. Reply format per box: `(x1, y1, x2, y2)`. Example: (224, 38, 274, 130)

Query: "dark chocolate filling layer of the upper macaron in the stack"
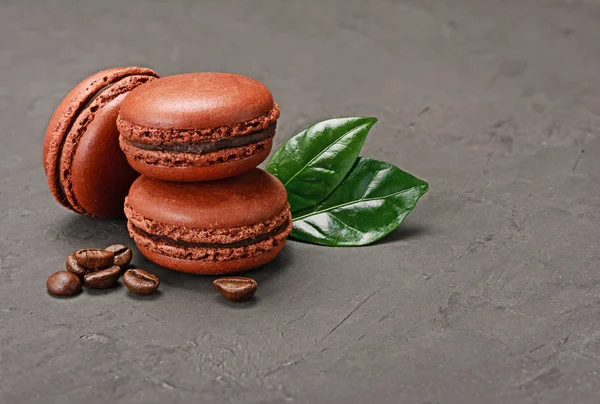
(128, 123, 277, 154)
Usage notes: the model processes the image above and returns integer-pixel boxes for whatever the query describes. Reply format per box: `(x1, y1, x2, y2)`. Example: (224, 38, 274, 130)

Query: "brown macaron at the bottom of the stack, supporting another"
(125, 168, 292, 275)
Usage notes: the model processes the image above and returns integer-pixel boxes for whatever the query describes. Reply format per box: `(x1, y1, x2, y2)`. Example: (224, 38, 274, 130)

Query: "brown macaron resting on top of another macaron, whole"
(117, 73, 279, 182)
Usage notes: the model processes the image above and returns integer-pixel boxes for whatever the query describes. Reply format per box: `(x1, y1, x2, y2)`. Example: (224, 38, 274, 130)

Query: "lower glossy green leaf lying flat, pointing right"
(292, 158, 429, 246)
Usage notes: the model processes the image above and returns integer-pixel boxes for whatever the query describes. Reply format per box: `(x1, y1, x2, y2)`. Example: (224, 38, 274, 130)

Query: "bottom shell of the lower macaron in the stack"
(136, 241, 285, 275)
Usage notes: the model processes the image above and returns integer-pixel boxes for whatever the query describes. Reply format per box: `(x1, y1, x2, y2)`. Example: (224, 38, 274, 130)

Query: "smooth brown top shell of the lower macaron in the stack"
(126, 168, 287, 229)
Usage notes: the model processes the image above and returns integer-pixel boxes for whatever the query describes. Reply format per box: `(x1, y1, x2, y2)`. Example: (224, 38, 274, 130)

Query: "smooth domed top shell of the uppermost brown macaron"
(120, 73, 274, 129)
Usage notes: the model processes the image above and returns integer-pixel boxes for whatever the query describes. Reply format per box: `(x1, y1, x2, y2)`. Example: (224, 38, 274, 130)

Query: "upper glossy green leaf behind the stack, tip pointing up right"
(266, 117, 377, 212)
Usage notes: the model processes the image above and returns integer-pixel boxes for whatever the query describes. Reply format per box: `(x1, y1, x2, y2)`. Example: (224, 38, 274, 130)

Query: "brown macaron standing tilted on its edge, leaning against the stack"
(42, 67, 158, 218)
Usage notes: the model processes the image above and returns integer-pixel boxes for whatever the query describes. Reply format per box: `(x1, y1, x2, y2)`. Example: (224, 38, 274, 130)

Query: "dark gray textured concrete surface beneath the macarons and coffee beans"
(0, 0, 600, 404)
